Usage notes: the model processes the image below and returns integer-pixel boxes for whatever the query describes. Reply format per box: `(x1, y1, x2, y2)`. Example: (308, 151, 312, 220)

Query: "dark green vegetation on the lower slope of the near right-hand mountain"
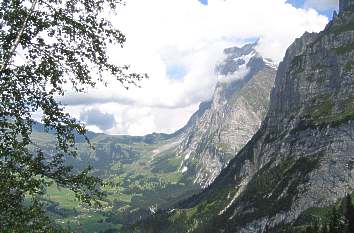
(126, 154, 321, 233)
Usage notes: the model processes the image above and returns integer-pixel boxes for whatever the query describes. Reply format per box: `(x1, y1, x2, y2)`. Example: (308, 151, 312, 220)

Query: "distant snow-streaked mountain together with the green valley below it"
(33, 43, 277, 232)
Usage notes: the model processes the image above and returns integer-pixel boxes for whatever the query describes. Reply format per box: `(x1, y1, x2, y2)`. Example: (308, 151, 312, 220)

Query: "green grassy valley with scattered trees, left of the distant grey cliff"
(33, 130, 200, 233)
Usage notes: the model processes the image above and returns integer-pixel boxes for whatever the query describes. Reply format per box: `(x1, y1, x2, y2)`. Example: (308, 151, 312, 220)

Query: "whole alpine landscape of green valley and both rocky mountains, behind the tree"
(33, 0, 354, 233)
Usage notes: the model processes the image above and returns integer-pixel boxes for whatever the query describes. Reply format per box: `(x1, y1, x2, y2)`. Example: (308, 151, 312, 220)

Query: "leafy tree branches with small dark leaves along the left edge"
(0, 0, 143, 232)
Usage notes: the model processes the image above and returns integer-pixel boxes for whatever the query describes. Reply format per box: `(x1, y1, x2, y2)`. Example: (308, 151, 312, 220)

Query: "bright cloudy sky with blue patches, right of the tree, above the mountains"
(60, 0, 337, 135)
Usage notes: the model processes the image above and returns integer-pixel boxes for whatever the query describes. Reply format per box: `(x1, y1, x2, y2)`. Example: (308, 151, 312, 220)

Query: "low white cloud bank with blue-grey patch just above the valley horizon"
(67, 103, 198, 135)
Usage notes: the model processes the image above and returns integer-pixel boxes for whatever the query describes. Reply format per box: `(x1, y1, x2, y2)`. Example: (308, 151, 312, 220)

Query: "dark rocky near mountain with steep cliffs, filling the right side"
(129, 0, 354, 233)
